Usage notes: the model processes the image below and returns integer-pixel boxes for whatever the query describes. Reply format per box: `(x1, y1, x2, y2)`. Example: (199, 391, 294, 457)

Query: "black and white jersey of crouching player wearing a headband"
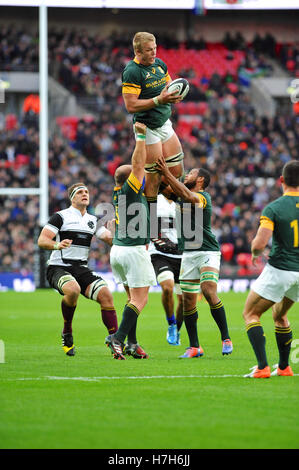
(45, 206, 105, 266)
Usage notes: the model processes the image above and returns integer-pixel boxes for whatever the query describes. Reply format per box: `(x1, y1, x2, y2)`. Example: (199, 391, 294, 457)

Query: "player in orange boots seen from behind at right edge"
(243, 160, 299, 379)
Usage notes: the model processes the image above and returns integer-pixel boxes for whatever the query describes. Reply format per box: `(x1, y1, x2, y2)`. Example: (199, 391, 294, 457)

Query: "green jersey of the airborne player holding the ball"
(122, 58, 171, 129)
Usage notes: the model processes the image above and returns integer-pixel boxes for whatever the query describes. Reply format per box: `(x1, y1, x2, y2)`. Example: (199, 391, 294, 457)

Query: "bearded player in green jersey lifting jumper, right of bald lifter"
(158, 157, 233, 359)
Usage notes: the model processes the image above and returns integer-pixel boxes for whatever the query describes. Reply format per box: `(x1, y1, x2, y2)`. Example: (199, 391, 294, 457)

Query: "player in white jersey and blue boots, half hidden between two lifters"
(148, 194, 183, 346)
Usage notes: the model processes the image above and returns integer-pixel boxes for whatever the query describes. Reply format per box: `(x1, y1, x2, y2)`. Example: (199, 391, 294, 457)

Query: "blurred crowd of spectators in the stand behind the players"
(0, 28, 299, 275)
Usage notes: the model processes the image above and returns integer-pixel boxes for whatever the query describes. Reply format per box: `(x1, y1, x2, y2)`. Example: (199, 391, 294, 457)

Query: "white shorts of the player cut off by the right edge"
(251, 264, 299, 303)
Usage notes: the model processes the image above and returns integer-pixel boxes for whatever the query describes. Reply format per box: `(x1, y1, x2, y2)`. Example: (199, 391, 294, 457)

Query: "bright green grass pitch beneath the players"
(0, 290, 299, 449)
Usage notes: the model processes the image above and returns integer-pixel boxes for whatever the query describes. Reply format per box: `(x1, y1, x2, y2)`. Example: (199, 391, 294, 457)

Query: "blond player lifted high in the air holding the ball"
(122, 32, 184, 238)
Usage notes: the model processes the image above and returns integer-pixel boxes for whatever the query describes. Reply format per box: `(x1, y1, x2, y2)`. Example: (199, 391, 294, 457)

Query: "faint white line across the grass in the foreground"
(0, 374, 299, 382)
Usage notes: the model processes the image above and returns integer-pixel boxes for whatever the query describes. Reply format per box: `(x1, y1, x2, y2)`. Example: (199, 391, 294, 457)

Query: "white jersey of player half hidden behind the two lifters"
(148, 194, 182, 258)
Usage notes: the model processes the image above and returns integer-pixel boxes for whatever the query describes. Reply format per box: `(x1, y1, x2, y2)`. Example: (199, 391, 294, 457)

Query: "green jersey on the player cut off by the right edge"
(260, 191, 299, 271)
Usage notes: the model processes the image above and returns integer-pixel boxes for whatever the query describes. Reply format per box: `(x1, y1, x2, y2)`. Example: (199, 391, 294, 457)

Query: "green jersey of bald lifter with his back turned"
(113, 173, 150, 246)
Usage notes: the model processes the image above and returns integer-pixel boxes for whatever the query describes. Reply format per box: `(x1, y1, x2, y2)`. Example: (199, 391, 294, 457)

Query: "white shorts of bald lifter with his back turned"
(110, 245, 157, 287)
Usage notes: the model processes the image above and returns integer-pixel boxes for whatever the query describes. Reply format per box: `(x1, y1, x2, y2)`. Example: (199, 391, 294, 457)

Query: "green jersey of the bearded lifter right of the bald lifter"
(178, 191, 220, 251)
